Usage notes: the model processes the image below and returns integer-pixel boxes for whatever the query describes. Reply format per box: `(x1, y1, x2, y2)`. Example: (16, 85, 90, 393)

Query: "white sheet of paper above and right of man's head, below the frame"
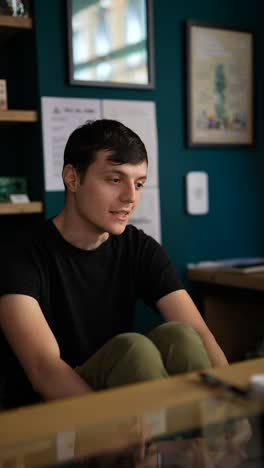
(102, 99, 159, 187)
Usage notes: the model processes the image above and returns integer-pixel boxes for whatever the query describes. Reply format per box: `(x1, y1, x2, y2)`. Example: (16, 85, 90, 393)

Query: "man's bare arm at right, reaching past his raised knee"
(156, 289, 228, 366)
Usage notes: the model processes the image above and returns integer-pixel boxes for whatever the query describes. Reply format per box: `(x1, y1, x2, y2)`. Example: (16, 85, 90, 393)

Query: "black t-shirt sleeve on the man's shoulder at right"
(137, 231, 184, 307)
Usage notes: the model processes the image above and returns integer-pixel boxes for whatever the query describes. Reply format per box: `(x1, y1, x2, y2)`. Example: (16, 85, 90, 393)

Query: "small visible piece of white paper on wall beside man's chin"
(129, 187, 161, 243)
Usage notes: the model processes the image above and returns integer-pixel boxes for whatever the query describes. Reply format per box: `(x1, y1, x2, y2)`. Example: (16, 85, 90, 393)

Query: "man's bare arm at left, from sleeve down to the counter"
(0, 294, 92, 400)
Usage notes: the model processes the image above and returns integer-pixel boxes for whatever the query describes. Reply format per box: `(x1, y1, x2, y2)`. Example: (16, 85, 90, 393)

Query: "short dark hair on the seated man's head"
(63, 119, 148, 175)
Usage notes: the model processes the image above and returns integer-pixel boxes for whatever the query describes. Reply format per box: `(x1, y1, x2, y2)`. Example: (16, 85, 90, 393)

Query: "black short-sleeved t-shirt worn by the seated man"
(0, 220, 182, 405)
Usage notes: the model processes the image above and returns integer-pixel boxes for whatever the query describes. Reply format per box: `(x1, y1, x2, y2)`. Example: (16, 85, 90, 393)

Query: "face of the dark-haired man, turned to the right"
(71, 150, 147, 235)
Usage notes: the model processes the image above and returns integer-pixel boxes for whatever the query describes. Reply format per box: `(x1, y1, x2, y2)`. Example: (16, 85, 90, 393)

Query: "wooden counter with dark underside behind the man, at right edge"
(188, 268, 264, 362)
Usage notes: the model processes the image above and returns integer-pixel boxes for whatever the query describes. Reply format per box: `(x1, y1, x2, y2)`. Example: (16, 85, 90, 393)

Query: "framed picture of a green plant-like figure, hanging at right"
(186, 21, 254, 147)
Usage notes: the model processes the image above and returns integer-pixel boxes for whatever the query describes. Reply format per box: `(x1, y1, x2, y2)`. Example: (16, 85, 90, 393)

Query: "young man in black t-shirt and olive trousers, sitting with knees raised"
(0, 120, 227, 407)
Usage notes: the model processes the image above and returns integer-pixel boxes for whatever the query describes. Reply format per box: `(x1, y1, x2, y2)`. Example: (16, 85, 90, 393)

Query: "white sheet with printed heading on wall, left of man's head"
(41, 97, 101, 191)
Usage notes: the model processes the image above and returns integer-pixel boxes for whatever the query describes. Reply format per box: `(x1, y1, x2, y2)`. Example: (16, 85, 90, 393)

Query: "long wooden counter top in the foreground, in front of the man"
(0, 359, 264, 468)
